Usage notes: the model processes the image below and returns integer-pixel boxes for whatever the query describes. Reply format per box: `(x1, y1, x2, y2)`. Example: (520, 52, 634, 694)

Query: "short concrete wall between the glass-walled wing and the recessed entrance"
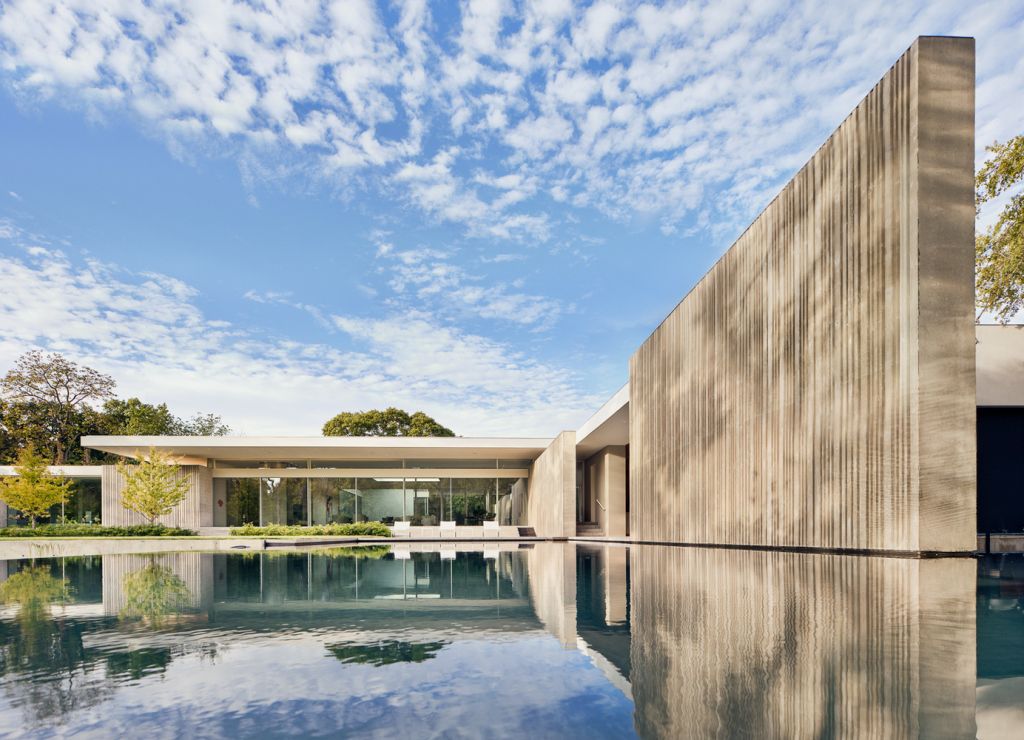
(526, 432, 575, 537)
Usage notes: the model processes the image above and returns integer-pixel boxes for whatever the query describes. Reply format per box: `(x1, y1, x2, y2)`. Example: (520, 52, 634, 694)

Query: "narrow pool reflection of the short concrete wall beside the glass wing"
(525, 542, 577, 648)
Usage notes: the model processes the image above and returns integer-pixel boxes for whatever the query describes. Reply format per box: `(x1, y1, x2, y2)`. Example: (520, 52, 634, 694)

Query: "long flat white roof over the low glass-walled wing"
(82, 436, 552, 461)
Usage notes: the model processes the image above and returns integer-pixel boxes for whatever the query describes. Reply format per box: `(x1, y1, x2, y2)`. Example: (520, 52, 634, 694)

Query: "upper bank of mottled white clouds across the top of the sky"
(0, 0, 1024, 241)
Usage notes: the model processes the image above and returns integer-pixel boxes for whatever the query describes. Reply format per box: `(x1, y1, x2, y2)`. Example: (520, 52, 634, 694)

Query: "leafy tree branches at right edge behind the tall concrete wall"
(975, 135, 1024, 321)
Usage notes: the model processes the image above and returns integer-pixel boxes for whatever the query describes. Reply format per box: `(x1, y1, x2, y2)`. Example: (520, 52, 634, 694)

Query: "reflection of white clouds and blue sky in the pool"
(59, 635, 633, 738)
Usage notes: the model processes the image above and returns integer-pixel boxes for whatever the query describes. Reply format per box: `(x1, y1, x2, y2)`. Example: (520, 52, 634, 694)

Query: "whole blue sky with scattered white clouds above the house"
(0, 0, 1024, 435)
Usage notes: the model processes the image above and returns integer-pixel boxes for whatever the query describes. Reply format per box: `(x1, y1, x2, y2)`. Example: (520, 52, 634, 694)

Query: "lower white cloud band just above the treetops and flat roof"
(0, 234, 600, 436)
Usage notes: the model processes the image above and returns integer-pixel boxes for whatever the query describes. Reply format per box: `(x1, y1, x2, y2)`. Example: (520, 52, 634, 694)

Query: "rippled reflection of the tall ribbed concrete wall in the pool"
(630, 547, 976, 738)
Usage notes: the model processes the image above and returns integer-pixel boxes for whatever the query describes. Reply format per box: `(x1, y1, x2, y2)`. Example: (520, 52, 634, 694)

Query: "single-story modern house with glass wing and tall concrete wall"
(2, 37, 1024, 554)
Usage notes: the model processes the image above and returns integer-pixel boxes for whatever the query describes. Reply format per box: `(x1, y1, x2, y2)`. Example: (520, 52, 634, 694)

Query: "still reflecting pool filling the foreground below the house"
(0, 543, 1024, 738)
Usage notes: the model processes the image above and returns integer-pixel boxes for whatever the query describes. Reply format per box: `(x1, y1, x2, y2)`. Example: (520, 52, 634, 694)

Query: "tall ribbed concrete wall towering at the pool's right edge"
(630, 38, 975, 551)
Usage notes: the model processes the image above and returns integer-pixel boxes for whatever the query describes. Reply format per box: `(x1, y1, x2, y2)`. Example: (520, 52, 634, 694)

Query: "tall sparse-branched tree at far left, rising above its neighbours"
(0, 350, 116, 465)
